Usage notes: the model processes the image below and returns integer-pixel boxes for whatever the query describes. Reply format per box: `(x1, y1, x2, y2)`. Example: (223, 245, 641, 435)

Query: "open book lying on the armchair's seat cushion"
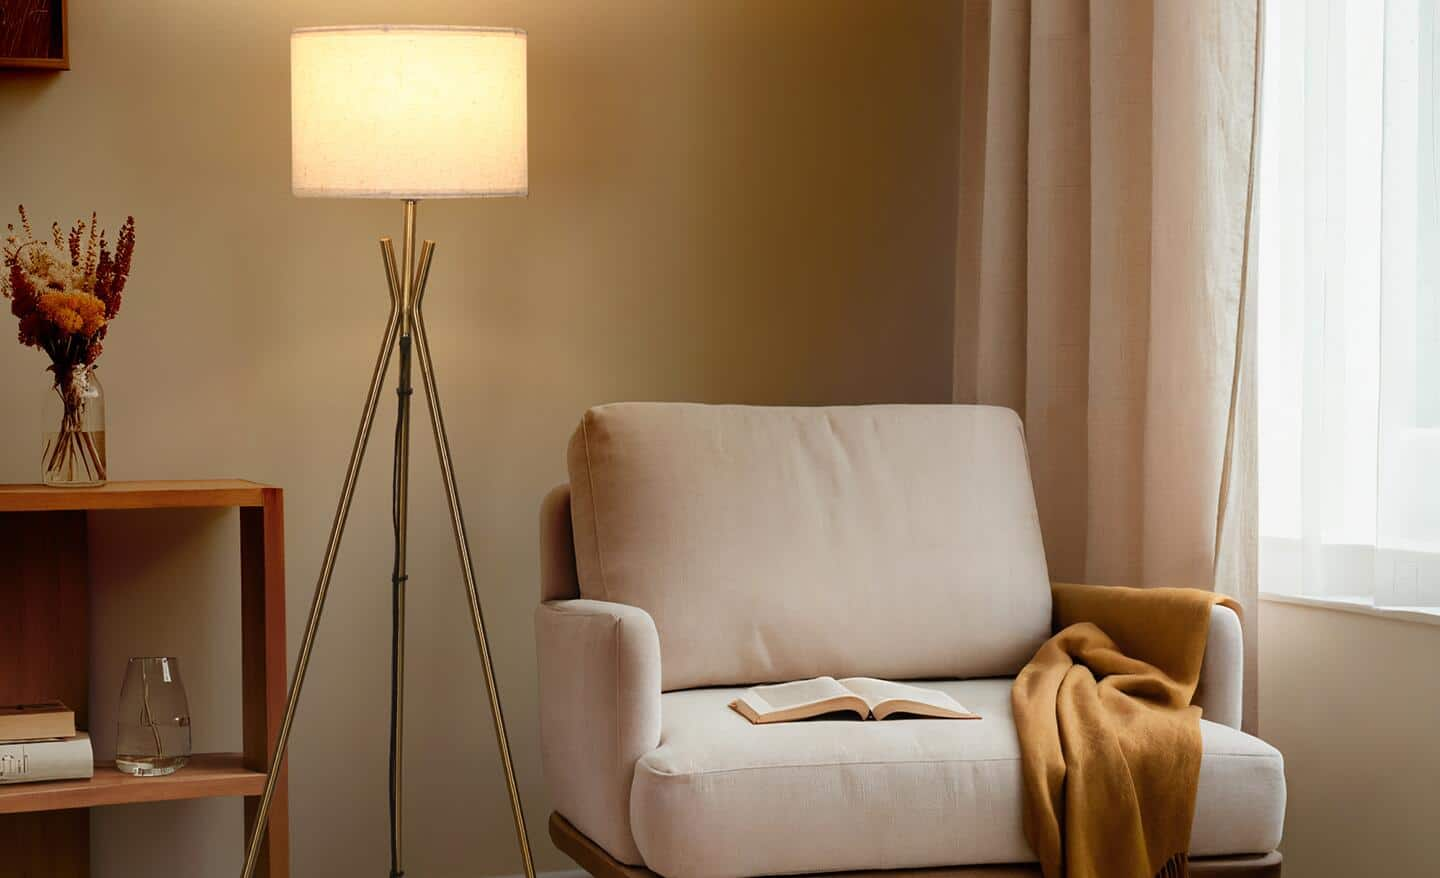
(730, 676, 979, 723)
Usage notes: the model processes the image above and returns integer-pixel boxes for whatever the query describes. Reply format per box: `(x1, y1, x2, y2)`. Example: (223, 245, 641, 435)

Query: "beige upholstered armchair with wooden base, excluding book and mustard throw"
(536, 403, 1284, 878)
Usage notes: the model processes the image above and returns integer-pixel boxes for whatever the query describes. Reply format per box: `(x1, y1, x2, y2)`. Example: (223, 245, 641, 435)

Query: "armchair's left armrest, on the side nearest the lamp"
(536, 600, 660, 865)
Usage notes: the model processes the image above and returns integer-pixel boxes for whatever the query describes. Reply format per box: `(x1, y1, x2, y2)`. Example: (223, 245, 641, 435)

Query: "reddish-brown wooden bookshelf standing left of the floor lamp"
(0, 479, 289, 878)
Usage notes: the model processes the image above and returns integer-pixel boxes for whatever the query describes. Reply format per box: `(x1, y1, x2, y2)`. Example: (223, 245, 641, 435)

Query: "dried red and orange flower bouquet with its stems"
(0, 204, 135, 484)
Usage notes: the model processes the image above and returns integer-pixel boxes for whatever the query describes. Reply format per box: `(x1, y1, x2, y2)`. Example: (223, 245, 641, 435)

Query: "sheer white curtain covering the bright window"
(1257, 0, 1440, 607)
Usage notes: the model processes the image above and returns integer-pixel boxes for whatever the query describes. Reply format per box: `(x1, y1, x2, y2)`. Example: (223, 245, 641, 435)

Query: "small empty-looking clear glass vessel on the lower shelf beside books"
(115, 656, 190, 777)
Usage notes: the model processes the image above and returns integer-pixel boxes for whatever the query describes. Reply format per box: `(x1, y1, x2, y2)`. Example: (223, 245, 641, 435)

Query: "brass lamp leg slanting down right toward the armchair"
(413, 240, 536, 878)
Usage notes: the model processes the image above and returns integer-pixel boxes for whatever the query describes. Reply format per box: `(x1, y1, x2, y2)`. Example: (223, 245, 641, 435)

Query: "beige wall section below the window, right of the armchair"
(1260, 602, 1440, 878)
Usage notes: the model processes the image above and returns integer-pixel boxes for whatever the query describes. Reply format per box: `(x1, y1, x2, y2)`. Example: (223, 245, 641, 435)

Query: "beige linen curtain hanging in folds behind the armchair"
(953, 0, 1260, 725)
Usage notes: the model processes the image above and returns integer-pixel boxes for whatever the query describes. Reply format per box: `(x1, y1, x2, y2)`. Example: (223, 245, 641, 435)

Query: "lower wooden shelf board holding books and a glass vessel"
(0, 753, 265, 815)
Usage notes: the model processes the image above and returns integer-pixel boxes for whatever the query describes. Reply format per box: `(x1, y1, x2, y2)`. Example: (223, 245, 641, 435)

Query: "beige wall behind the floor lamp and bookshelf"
(0, 0, 959, 878)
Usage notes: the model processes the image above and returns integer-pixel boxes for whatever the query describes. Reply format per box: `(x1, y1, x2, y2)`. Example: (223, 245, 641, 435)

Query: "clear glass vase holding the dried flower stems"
(40, 364, 105, 488)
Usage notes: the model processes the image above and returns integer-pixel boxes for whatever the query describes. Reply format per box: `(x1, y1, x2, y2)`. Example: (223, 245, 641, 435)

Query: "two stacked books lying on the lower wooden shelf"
(0, 701, 95, 783)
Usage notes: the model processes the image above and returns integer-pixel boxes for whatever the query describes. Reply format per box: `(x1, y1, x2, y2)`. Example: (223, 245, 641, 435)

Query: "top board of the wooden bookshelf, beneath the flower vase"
(0, 479, 268, 512)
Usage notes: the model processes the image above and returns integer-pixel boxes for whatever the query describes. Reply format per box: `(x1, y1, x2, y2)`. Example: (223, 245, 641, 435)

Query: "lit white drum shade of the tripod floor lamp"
(289, 26, 528, 199)
